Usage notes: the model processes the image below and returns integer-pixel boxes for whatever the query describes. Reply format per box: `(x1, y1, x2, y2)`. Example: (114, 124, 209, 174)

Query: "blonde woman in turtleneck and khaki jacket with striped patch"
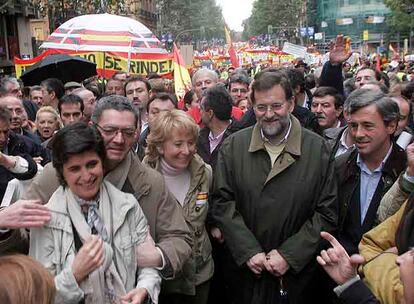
(144, 110, 214, 304)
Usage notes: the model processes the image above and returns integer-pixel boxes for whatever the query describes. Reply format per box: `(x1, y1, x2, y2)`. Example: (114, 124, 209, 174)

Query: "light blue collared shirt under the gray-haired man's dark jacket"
(357, 144, 392, 225)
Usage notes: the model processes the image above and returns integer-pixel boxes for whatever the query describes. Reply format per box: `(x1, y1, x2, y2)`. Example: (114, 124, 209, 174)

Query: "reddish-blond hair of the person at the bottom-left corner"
(0, 255, 56, 304)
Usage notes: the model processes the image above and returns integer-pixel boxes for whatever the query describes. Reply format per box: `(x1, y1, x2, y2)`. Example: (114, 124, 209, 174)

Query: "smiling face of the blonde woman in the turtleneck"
(160, 130, 196, 170)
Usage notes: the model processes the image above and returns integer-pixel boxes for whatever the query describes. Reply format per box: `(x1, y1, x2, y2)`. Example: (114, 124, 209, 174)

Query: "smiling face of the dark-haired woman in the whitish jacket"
(63, 151, 103, 200)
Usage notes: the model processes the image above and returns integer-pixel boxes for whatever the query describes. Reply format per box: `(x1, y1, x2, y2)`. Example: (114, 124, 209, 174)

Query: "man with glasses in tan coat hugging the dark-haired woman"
(1, 95, 191, 278)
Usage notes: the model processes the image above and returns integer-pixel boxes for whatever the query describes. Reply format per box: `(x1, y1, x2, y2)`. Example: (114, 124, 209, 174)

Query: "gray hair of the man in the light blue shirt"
(344, 87, 400, 124)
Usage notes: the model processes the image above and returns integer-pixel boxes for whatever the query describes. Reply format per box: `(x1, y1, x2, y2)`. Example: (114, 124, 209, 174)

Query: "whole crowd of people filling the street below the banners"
(0, 36, 414, 304)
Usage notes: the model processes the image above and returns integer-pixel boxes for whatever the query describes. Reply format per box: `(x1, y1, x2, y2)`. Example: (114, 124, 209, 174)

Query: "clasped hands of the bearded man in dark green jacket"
(246, 249, 289, 277)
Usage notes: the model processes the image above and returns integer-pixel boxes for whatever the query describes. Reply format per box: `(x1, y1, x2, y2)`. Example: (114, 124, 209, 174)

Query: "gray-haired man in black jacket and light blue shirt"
(335, 88, 406, 254)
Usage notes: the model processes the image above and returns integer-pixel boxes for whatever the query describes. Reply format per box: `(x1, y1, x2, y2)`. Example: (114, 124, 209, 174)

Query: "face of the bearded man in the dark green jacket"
(254, 85, 294, 140)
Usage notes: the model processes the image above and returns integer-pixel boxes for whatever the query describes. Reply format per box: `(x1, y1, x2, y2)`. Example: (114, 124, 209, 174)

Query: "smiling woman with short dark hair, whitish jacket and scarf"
(30, 123, 161, 304)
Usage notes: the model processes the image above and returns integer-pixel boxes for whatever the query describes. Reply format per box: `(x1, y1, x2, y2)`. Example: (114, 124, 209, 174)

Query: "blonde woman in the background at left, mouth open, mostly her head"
(36, 106, 63, 142)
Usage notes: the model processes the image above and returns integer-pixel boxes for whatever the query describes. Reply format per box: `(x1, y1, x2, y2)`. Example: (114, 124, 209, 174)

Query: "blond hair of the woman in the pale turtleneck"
(146, 110, 199, 162)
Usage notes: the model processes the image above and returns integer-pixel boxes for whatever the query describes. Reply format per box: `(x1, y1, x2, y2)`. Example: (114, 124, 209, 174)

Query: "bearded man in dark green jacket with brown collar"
(212, 71, 338, 304)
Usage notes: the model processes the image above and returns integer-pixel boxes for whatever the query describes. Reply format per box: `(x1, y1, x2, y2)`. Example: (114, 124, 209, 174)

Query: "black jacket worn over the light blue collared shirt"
(335, 143, 407, 254)
